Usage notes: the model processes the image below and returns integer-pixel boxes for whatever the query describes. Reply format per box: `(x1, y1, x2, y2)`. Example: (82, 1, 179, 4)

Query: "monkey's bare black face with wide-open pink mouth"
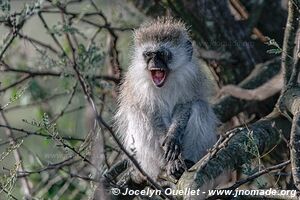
(143, 49, 172, 87)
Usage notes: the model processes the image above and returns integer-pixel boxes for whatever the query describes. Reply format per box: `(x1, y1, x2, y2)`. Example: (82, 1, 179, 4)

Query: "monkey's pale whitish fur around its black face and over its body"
(115, 43, 217, 177)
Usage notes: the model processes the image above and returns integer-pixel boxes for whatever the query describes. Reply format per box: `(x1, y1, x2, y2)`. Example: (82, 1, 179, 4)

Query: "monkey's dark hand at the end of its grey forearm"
(162, 134, 181, 161)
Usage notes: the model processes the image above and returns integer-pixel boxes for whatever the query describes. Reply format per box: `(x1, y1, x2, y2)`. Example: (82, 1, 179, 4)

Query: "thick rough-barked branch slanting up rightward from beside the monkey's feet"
(177, 111, 290, 199)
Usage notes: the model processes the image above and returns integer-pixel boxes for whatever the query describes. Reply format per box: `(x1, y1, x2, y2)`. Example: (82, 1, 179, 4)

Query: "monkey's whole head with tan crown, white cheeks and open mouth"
(130, 17, 193, 88)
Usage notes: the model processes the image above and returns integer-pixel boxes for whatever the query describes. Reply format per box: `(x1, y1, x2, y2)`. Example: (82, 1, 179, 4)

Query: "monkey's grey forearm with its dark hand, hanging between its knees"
(163, 103, 191, 161)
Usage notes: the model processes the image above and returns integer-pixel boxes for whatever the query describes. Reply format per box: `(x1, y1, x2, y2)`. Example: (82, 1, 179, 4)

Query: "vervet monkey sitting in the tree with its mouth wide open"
(115, 18, 217, 178)
